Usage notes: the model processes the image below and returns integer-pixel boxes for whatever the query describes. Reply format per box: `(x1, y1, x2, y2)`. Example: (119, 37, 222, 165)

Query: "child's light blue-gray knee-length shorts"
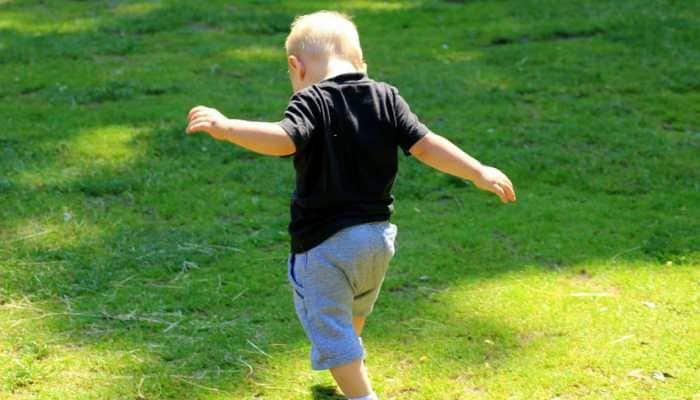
(287, 221, 396, 370)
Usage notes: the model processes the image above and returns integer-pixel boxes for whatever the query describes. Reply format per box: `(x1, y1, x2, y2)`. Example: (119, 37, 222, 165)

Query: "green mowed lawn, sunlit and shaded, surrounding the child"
(0, 0, 700, 400)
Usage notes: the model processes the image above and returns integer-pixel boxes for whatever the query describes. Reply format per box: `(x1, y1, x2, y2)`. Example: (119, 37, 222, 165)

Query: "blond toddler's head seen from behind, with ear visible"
(285, 11, 367, 90)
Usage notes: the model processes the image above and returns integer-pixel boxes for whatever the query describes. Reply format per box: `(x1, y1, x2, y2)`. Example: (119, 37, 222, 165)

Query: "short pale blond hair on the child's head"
(284, 11, 365, 71)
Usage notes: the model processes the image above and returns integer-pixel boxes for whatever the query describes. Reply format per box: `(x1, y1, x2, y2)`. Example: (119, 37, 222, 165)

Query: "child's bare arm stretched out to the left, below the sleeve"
(186, 106, 296, 156)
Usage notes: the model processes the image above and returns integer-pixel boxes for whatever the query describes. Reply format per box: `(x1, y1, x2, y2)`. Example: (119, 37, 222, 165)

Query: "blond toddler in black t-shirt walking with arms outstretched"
(186, 11, 515, 400)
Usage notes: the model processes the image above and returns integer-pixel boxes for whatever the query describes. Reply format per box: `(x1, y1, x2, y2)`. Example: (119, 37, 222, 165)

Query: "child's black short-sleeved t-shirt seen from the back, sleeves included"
(279, 72, 429, 253)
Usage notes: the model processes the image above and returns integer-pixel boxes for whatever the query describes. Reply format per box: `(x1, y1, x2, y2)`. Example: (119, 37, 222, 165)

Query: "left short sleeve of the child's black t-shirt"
(279, 91, 320, 153)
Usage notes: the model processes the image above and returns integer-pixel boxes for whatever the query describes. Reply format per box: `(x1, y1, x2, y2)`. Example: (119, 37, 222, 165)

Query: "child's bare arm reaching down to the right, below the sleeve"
(409, 132, 515, 203)
